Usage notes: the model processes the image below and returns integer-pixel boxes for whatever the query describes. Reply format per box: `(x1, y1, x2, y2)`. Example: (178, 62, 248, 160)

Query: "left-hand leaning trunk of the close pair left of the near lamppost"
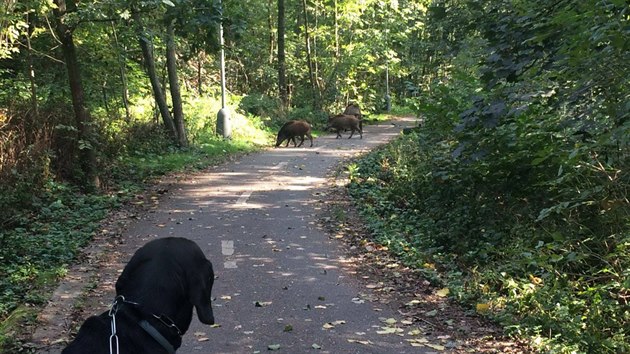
(131, 10, 178, 142)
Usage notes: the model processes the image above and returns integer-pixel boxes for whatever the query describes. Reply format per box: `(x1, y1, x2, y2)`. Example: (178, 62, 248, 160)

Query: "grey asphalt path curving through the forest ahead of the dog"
(38, 120, 426, 354)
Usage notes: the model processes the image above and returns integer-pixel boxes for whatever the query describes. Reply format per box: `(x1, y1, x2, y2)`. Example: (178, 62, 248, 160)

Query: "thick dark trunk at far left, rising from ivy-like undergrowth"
(53, 0, 99, 190)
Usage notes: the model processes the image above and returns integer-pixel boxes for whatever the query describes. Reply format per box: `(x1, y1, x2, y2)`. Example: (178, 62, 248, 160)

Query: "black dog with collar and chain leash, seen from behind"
(62, 237, 214, 354)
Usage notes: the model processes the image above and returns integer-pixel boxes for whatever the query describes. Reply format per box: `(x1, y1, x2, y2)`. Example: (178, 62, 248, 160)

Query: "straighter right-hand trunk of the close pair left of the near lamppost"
(166, 20, 188, 147)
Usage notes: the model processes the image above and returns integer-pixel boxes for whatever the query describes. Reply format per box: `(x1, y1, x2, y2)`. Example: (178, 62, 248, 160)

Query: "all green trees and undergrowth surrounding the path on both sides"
(0, 0, 630, 353)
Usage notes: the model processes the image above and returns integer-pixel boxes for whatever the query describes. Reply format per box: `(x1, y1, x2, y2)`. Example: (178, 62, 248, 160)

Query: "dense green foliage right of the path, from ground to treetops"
(351, 0, 630, 353)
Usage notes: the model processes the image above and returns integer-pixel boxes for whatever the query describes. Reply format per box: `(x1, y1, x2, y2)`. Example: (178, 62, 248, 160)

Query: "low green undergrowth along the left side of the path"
(0, 94, 271, 352)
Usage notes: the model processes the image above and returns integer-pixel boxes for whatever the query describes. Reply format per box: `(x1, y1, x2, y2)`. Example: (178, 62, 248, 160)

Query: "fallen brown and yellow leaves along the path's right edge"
(321, 180, 533, 354)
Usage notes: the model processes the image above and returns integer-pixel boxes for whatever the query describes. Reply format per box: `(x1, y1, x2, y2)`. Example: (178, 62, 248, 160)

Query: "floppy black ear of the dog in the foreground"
(190, 258, 214, 324)
